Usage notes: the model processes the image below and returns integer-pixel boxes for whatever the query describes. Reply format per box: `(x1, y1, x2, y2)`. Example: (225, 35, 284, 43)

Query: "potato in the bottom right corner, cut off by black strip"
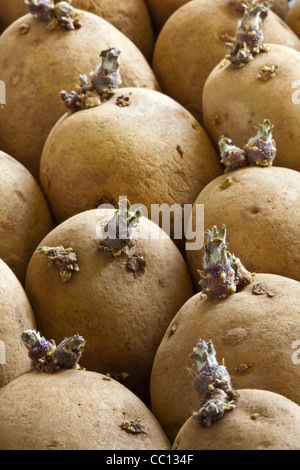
(172, 389, 300, 451)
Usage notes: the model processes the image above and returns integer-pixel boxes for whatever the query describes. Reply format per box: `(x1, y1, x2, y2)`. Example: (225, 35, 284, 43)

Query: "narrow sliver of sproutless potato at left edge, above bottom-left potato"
(0, 259, 36, 388)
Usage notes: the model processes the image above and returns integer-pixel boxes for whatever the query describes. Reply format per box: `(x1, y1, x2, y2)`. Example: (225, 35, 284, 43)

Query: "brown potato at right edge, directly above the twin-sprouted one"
(203, 44, 300, 171)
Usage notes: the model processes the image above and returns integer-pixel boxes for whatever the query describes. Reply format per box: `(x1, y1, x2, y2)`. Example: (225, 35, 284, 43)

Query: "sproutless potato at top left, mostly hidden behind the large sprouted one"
(0, 0, 154, 60)
